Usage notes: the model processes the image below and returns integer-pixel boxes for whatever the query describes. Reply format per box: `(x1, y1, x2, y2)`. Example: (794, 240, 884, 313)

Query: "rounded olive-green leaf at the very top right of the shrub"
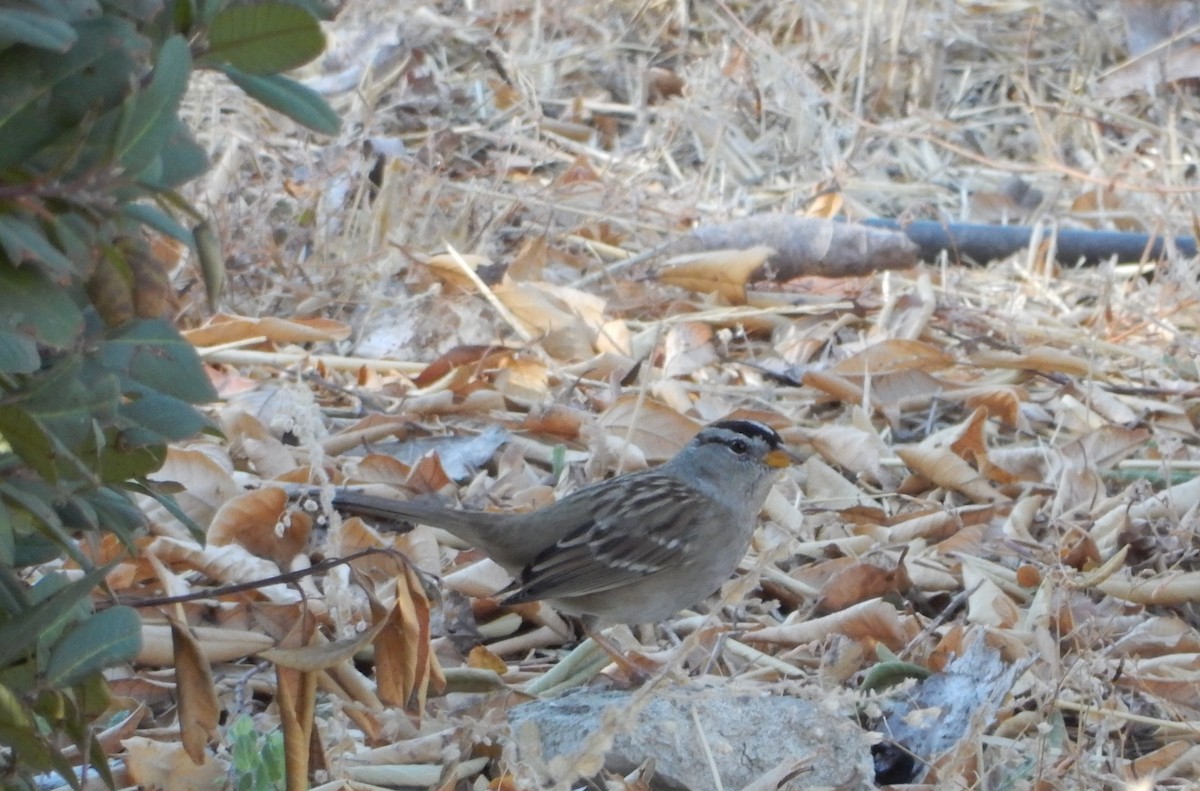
(202, 2, 325, 76)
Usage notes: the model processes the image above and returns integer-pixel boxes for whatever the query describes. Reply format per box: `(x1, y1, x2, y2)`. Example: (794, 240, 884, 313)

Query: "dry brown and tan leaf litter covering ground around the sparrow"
(77, 0, 1200, 787)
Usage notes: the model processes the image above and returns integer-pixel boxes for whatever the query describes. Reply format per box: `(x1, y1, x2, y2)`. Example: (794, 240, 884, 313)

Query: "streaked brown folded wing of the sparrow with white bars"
(508, 471, 712, 603)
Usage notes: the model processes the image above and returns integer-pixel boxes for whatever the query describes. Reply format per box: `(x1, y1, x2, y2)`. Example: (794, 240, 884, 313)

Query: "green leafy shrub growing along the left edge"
(0, 0, 338, 789)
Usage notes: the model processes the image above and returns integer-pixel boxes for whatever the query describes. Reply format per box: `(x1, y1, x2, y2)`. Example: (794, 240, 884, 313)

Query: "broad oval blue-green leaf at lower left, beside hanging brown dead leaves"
(46, 607, 142, 688)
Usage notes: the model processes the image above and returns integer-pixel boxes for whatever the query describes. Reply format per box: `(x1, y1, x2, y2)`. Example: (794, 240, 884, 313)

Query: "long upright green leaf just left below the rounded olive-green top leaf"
(116, 36, 192, 175)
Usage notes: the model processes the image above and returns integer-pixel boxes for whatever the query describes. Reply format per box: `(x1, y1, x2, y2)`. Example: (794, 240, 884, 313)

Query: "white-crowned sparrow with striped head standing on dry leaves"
(334, 420, 790, 623)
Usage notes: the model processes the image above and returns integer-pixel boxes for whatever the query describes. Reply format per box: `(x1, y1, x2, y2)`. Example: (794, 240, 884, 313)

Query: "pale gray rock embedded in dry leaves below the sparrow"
(505, 684, 874, 791)
